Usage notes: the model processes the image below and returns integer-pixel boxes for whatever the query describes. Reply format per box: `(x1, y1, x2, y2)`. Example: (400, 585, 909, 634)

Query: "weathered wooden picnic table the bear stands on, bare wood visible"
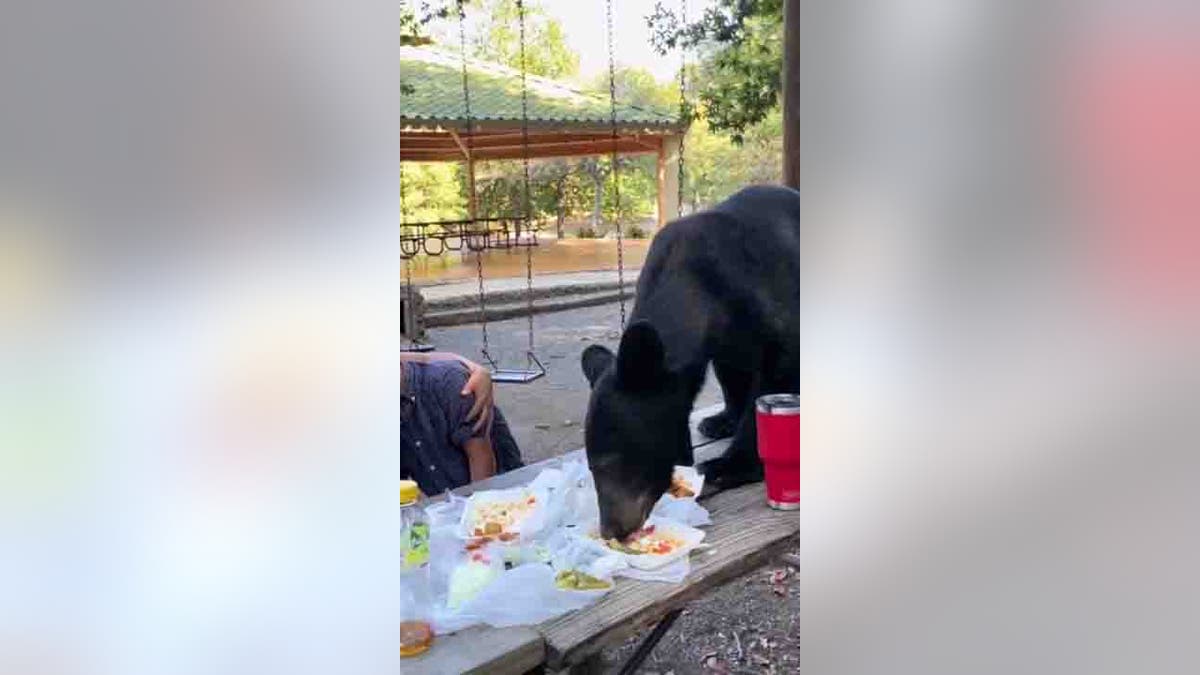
(401, 405, 800, 675)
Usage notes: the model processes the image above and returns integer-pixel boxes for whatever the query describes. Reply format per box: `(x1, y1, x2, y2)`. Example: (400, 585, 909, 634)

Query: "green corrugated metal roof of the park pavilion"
(400, 47, 679, 131)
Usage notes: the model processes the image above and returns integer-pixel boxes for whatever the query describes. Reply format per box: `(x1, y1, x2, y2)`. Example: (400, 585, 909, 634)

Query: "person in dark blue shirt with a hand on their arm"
(400, 352, 523, 495)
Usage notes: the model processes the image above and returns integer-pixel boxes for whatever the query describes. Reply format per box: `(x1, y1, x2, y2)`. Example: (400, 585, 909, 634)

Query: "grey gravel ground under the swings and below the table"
(428, 304, 800, 675)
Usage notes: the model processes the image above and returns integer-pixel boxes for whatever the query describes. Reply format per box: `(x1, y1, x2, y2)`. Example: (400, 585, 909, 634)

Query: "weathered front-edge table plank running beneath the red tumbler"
(539, 484, 800, 669)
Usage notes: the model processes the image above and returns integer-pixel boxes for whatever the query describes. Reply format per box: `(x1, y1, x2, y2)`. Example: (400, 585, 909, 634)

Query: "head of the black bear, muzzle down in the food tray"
(581, 321, 691, 539)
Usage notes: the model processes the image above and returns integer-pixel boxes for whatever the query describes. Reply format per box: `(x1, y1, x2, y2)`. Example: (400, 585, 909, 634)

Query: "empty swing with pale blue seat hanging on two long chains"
(457, 0, 546, 384)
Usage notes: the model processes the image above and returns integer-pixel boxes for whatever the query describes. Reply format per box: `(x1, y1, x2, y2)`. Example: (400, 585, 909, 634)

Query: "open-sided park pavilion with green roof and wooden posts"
(400, 46, 686, 226)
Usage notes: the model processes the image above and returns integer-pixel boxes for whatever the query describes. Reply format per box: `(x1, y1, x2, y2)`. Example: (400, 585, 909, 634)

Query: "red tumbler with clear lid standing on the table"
(755, 394, 800, 510)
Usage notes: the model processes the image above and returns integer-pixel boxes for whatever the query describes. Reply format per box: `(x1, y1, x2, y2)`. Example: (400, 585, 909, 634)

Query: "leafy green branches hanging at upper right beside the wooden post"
(646, 0, 784, 144)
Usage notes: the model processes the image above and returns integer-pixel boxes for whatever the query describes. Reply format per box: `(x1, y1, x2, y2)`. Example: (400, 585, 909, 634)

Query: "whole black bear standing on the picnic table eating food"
(582, 186, 800, 538)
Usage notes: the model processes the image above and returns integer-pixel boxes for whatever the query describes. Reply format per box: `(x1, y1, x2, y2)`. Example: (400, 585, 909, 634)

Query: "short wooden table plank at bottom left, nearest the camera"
(400, 626, 546, 675)
